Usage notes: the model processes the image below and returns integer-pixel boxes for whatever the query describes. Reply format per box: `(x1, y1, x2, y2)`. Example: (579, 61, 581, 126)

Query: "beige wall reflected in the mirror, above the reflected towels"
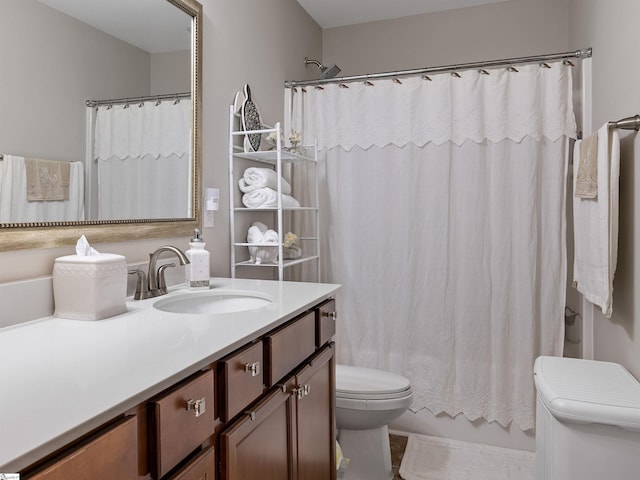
(0, 0, 149, 161)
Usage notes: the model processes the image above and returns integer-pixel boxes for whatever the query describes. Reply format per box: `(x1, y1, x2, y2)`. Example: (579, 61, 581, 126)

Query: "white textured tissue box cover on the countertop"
(53, 253, 127, 320)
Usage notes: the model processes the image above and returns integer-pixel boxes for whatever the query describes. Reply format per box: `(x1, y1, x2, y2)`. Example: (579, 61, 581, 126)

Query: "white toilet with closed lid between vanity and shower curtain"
(336, 365, 413, 480)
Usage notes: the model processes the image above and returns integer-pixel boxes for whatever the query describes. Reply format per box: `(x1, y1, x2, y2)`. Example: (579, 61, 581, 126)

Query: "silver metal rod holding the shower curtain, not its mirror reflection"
(284, 48, 592, 88)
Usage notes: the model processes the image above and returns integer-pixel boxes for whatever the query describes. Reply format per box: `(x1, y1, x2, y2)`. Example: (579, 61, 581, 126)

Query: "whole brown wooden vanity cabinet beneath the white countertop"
(21, 300, 336, 480)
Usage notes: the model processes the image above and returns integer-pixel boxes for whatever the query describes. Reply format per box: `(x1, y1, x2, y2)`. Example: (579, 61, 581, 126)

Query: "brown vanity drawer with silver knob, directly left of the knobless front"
(218, 342, 264, 422)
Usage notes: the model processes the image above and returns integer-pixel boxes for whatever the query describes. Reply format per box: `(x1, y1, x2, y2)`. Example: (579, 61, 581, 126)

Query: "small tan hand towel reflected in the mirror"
(24, 158, 71, 202)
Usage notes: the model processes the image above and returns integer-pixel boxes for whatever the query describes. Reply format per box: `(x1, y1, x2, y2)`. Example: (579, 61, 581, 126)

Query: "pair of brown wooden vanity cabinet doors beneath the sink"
(220, 345, 336, 480)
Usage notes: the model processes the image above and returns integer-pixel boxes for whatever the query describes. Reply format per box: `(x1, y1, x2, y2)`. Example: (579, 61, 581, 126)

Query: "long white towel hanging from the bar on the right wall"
(573, 124, 620, 318)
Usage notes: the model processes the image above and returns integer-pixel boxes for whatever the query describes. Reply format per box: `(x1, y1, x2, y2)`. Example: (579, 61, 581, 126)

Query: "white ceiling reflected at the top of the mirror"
(38, 0, 191, 53)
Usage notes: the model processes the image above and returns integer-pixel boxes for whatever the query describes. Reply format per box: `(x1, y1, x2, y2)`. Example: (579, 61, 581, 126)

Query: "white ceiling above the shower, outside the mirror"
(298, 0, 508, 28)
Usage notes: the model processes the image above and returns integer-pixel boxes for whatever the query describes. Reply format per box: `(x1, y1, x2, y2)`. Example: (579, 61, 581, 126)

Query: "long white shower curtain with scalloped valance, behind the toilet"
(288, 62, 575, 430)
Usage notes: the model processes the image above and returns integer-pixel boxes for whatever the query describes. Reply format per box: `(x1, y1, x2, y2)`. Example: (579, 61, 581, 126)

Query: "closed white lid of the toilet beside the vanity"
(336, 365, 411, 398)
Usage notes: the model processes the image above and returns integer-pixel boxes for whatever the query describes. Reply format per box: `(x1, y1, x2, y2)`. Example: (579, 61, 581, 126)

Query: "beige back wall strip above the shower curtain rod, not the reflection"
(323, 0, 569, 75)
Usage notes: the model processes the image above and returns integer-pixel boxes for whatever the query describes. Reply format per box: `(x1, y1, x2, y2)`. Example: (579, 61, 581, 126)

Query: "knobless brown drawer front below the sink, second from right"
(264, 311, 316, 387)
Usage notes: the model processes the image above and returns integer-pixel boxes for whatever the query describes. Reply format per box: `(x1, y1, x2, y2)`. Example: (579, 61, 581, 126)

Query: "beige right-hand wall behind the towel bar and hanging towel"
(570, 0, 640, 378)
